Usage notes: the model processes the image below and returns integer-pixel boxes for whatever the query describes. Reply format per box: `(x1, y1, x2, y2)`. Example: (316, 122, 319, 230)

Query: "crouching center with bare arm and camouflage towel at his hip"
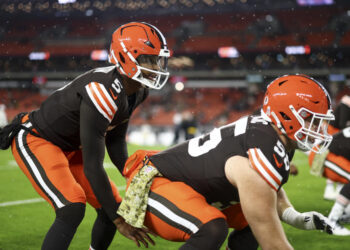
(118, 75, 334, 250)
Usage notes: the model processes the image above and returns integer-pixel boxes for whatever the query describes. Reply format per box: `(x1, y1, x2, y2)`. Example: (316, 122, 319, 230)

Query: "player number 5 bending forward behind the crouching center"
(2, 22, 170, 250)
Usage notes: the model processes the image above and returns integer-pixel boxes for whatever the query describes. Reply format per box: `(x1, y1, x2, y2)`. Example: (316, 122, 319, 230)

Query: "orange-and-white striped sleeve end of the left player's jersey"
(85, 82, 118, 123)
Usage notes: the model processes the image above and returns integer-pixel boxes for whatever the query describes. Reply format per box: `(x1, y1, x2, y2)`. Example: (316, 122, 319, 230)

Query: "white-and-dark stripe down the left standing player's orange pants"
(16, 123, 69, 209)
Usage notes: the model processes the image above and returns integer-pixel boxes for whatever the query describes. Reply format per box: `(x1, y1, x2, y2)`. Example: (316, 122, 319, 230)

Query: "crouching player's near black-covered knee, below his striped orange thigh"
(180, 218, 228, 250)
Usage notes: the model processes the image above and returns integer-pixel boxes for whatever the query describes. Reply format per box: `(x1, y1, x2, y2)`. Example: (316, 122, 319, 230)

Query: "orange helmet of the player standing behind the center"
(108, 22, 170, 89)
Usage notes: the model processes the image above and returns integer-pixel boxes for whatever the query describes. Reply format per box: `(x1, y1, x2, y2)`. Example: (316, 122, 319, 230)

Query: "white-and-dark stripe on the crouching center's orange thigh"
(147, 192, 202, 234)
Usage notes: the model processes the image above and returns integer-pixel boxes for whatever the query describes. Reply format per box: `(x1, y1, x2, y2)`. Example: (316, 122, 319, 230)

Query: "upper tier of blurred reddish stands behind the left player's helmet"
(0, 6, 350, 72)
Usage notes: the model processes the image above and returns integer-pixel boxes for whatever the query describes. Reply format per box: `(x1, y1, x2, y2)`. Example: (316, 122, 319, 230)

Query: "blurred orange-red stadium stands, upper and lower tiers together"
(0, 3, 350, 129)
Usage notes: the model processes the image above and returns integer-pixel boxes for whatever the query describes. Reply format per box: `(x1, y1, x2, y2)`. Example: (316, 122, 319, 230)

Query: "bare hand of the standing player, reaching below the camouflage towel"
(113, 217, 156, 248)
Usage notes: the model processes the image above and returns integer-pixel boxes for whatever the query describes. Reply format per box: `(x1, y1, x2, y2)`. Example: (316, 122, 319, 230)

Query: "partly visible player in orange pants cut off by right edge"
(309, 127, 350, 236)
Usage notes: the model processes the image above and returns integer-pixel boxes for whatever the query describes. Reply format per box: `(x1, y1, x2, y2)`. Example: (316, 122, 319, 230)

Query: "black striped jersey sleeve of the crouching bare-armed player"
(243, 128, 289, 191)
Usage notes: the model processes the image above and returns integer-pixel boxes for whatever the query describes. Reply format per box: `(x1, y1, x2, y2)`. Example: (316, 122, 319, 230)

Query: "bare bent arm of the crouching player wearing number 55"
(225, 156, 293, 250)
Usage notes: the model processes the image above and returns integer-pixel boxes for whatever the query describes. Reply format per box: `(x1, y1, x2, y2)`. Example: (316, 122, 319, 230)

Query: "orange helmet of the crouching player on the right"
(261, 75, 334, 153)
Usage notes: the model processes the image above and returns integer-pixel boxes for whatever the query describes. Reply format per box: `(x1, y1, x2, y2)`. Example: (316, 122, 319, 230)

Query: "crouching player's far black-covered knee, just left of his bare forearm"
(227, 226, 259, 250)
